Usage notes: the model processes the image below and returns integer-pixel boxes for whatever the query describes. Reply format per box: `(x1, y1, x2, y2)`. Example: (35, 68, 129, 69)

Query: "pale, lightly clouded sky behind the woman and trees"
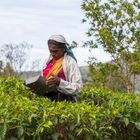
(0, 0, 110, 70)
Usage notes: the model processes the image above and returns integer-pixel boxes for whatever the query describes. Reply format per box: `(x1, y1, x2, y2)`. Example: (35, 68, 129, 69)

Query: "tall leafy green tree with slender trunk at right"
(82, 0, 140, 92)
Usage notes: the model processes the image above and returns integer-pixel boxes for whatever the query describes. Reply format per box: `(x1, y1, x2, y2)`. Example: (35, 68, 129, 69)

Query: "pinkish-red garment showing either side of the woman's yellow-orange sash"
(43, 60, 66, 80)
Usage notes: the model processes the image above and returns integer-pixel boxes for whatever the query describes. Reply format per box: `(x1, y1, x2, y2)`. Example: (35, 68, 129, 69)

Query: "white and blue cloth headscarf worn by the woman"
(49, 35, 77, 62)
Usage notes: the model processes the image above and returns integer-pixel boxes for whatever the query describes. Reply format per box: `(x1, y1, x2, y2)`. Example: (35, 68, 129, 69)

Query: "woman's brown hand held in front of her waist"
(46, 76, 60, 87)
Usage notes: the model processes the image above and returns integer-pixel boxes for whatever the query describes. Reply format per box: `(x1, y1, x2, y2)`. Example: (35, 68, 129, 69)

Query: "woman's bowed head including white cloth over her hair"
(48, 35, 67, 60)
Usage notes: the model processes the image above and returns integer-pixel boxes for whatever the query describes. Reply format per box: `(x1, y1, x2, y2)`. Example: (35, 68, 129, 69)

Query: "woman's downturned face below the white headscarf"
(48, 44, 66, 60)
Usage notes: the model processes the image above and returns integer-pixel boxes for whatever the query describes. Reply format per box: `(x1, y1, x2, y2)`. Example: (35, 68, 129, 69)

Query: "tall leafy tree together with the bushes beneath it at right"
(82, 0, 140, 93)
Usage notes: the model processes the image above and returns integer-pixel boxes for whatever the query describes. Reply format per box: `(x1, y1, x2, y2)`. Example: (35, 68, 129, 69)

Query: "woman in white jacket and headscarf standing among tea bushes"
(43, 35, 82, 101)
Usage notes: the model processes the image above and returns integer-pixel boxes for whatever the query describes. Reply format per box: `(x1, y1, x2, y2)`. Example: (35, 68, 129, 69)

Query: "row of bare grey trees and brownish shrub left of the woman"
(0, 42, 40, 77)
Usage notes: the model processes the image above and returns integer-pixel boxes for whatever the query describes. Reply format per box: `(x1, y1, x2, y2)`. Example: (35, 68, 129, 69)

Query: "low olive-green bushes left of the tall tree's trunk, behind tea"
(89, 59, 127, 92)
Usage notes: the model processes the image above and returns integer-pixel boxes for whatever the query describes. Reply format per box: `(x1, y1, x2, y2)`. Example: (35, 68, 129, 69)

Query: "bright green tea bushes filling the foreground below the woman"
(0, 78, 140, 140)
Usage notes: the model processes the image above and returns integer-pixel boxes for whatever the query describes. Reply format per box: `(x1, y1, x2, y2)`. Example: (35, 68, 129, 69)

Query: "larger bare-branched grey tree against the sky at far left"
(0, 42, 32, 73)
